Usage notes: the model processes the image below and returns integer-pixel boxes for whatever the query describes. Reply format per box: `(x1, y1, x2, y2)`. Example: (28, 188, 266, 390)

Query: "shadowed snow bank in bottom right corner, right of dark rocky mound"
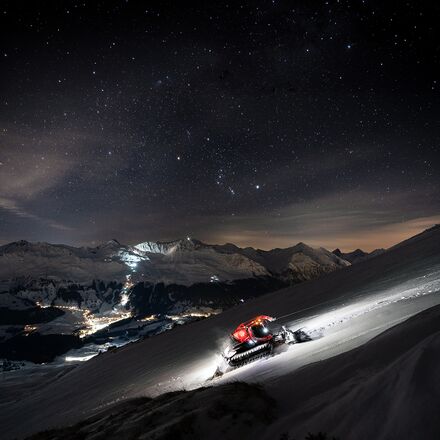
(266, 306, 440, 440)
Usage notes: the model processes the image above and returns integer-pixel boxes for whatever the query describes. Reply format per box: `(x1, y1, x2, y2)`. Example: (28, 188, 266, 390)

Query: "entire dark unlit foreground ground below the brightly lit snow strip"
(28, 306, 440, 440)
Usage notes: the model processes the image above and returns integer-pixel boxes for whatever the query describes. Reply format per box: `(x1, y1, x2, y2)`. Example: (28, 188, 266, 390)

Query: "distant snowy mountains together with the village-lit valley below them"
(0, 238, 350, 371)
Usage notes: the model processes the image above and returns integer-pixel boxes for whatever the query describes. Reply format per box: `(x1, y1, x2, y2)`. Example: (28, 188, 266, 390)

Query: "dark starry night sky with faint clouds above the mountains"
(0, 0, 440, 250)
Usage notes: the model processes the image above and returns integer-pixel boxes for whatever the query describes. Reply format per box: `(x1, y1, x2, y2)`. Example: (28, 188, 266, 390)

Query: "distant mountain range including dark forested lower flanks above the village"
(0, 238, 350, 320)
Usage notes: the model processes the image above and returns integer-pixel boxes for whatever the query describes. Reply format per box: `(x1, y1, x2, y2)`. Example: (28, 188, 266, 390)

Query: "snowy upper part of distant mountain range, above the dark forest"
(0, 238, 348, 286)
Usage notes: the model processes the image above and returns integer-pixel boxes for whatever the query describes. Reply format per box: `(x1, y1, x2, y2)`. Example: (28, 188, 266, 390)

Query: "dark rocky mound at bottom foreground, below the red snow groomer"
(25, 383, 276, 440)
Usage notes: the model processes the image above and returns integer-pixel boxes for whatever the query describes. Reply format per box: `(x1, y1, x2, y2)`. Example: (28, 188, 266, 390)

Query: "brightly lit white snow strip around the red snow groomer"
(183, 268, 440, 389)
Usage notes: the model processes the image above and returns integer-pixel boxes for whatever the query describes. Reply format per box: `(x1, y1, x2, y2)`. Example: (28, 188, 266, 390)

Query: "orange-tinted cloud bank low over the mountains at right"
(200, 191, 440, 251)
